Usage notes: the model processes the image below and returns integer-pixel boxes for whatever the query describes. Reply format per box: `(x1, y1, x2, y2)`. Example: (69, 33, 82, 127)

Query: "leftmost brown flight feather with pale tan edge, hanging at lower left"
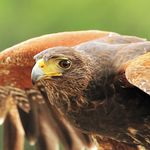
(0, 97, 24, 150)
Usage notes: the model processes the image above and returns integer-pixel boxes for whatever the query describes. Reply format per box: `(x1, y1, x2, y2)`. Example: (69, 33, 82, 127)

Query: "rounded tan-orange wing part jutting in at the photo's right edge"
(125, 52, 150, 95)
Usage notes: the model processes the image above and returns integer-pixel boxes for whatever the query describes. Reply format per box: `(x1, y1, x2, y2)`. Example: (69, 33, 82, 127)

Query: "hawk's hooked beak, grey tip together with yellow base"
(31, 58, 62, 83)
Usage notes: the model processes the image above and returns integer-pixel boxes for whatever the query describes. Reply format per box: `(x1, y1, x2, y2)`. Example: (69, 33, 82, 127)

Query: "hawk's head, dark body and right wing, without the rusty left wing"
(31, 33, 150, 149)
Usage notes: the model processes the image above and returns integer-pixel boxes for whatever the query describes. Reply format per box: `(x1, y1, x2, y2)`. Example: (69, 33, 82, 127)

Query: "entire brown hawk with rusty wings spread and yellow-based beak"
(0, 31, 150, 150)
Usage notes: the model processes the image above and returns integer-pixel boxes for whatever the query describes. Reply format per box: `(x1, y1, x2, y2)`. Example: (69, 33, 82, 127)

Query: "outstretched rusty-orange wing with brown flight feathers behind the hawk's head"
(0, 31, 109, 150)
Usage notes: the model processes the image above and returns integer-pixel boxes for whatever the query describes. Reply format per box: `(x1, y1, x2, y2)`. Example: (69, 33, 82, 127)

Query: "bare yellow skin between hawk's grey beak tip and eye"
(37, 58, 63, 77)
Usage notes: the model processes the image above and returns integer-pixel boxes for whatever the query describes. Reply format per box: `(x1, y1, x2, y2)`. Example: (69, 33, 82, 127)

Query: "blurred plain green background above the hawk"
(0, 0, 150, 150)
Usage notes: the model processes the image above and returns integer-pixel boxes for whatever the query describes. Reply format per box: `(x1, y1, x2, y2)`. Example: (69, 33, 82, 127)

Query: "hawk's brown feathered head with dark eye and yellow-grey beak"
(31, 47, 90, 108)
